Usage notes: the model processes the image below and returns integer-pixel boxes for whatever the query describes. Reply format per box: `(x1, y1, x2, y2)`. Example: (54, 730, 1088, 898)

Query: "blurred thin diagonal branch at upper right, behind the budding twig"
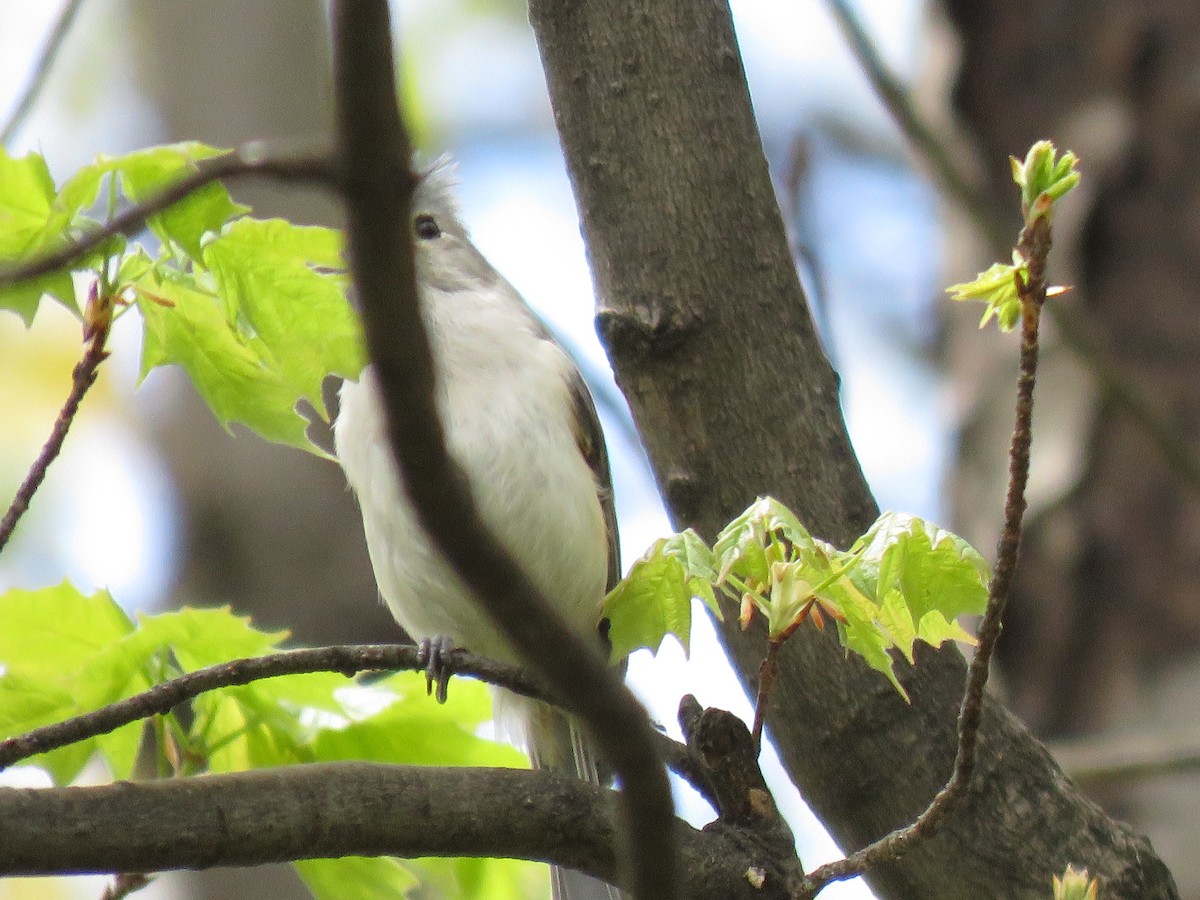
(828, 0, 1200, 493)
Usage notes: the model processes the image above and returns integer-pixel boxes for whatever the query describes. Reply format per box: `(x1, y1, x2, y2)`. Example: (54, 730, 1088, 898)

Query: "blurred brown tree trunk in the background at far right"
(947, 0, 1200, 896)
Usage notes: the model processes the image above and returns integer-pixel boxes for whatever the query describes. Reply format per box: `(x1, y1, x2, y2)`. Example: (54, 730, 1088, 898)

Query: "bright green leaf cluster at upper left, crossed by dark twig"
(0, 143, 365, 454)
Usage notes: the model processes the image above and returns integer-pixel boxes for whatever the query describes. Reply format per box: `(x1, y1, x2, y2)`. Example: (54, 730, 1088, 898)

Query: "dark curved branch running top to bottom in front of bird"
(334, 0, 677, 900)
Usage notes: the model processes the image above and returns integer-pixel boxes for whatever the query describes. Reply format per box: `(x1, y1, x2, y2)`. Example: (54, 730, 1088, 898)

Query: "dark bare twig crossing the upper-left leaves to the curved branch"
(0, 143, 337, 288)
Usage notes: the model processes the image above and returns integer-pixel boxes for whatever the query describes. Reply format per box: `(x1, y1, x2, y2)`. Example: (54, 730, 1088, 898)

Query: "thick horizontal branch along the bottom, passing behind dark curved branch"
(0, 763, 786, 900)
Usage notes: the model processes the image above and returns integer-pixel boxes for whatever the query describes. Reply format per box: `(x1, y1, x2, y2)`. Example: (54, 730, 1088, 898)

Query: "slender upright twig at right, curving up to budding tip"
(800, 216, 1050, 898)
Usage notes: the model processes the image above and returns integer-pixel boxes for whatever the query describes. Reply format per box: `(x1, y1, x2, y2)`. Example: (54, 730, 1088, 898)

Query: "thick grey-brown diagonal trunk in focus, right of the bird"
(530, 0, 1175, 900)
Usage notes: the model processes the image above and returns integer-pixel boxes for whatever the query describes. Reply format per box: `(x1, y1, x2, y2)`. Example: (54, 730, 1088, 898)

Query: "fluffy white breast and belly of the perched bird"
(335, 286, 607, 661)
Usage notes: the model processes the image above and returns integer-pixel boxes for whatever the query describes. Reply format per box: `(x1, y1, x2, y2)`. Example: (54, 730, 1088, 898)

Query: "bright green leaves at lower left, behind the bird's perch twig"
(0, 583, 545, 900)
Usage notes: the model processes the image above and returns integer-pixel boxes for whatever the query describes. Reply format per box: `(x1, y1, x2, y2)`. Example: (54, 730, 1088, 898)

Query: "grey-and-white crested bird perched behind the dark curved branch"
(335, 163, 620, 900)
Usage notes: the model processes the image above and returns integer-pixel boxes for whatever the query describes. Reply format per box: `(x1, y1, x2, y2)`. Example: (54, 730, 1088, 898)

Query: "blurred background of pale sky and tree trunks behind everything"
(0, 0, 1200, 900)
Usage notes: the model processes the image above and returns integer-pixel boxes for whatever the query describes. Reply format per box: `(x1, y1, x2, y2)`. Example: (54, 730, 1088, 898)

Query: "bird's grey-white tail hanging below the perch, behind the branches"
(496, 691, 625, 900)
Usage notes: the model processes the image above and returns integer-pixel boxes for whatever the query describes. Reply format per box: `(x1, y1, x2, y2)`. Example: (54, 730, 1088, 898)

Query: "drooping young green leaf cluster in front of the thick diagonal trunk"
(605, 497, 988, 696)
